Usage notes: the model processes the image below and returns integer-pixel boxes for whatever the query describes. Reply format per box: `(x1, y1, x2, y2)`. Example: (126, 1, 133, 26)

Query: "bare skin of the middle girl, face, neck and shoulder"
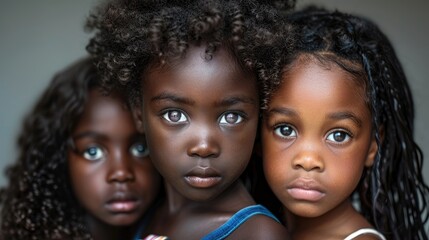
(137, 46, 287, 239)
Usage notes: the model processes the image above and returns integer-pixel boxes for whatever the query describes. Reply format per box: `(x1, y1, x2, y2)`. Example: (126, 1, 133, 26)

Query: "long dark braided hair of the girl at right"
(263, 6, 429, 240)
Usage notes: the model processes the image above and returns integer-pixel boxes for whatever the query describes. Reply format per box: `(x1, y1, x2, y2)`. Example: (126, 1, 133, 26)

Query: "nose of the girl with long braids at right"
(292, 143, 325, 172)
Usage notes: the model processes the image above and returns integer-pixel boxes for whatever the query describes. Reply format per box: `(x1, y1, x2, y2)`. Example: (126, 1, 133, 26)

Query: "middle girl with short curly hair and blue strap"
(88, 0, 294, 239)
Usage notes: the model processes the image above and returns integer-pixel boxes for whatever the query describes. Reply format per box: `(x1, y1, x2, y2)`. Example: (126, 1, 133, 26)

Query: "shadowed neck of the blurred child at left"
(86, 216, 138, 240)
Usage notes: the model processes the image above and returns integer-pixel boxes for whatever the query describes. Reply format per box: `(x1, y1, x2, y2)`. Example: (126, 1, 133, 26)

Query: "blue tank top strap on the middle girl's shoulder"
(202, 204, 280, 240)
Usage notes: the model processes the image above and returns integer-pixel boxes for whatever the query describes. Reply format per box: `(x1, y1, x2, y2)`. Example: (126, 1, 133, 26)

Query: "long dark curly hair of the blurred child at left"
(0, 58, 99, 239)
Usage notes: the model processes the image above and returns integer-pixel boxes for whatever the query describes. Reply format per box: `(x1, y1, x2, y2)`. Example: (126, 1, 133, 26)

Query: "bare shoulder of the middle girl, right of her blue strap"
(227, 215, 290, 240)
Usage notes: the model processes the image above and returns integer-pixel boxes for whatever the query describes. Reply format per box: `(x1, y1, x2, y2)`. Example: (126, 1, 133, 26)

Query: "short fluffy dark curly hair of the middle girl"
(87, 0, 295, 108)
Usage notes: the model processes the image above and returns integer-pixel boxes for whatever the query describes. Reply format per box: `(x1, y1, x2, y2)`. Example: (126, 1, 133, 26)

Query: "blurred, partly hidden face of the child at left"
(68, 90, 160, 226)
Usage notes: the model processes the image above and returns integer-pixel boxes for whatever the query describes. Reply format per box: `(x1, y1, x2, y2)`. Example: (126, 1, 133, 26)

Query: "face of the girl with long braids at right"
(262, 58, 377, 217)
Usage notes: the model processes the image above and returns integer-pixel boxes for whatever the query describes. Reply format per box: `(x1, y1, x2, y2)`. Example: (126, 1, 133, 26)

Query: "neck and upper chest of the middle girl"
(145, 181, 255, 239)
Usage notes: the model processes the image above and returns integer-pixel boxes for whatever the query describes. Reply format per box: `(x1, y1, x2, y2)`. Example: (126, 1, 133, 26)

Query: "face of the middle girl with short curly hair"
(143, 44, 259, 201)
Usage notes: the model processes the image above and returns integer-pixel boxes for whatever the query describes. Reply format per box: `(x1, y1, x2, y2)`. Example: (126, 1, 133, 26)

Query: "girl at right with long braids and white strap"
(262, 8, 429, 240)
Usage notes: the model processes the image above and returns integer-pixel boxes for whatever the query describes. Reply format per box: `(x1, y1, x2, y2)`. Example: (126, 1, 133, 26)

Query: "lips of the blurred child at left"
(105, 192, 140, 214)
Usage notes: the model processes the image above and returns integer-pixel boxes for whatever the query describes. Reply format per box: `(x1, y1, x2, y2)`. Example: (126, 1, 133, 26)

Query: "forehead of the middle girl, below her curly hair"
(141, 46, 256, 96)
